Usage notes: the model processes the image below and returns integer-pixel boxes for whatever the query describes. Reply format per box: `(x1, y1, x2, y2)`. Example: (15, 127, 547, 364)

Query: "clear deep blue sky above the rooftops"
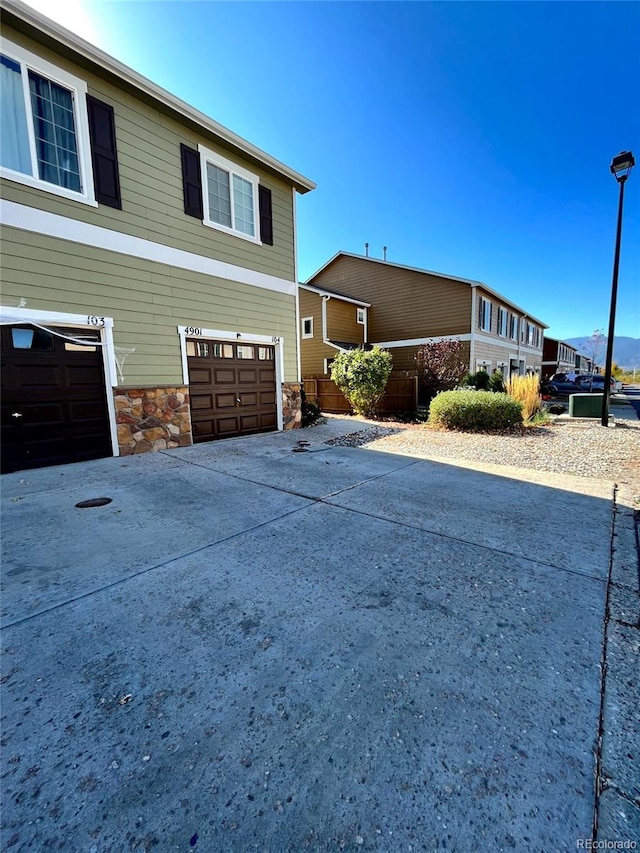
(22, 0, 640, 338)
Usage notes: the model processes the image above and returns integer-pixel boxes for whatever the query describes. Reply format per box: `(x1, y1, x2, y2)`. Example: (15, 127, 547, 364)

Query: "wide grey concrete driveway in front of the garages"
(2, 423, 632, 853)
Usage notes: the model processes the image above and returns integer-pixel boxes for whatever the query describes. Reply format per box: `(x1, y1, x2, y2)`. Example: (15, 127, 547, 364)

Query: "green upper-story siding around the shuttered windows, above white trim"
(2, 27, 295, 281)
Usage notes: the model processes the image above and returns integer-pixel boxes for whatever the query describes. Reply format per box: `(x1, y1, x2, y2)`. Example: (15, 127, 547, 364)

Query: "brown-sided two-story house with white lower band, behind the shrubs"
(304, 252, 547, 388)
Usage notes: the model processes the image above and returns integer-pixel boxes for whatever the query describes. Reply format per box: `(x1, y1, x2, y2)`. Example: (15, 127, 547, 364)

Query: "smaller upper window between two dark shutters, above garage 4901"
(198, 145, 260, 243)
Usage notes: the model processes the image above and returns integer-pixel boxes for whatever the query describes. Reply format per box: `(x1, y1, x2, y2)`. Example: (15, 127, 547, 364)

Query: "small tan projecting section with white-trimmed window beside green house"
(298, 284, 370, 379)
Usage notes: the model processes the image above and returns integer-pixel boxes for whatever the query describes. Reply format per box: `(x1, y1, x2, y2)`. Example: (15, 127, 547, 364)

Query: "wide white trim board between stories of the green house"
(0, 200, 296, 297)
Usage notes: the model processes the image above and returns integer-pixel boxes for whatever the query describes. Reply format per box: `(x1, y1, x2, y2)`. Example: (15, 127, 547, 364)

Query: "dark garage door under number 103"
(0, 325, 112, 473)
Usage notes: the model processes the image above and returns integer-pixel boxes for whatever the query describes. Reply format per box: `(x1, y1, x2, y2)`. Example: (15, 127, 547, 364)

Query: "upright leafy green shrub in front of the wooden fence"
(331, 346, 392, 415)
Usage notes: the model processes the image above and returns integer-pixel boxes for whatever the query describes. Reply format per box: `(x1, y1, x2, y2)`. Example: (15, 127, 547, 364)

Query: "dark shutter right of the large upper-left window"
(87, 95, 122, 210)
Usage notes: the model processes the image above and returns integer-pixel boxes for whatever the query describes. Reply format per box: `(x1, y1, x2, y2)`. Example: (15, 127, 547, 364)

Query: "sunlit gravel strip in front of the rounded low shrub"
(326, 421, 640, 490)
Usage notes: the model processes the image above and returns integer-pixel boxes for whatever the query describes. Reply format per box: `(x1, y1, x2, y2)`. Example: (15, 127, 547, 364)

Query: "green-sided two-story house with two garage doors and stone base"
(0, 0, 315, 470)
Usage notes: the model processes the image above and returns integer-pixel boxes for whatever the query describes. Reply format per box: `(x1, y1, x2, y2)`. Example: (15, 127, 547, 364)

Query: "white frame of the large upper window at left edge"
(0, 38, 98, 207)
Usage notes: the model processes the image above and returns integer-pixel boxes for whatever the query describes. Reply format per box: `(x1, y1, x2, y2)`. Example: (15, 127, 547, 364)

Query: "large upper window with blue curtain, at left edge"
(0, 40, 96, 205)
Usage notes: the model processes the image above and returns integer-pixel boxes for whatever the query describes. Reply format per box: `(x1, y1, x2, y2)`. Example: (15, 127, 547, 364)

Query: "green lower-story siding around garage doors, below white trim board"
(2, 228, 298, 385)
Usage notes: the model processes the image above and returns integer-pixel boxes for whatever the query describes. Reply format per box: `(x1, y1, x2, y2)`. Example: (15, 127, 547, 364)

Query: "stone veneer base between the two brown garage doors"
(114, 386, 193, 456)
